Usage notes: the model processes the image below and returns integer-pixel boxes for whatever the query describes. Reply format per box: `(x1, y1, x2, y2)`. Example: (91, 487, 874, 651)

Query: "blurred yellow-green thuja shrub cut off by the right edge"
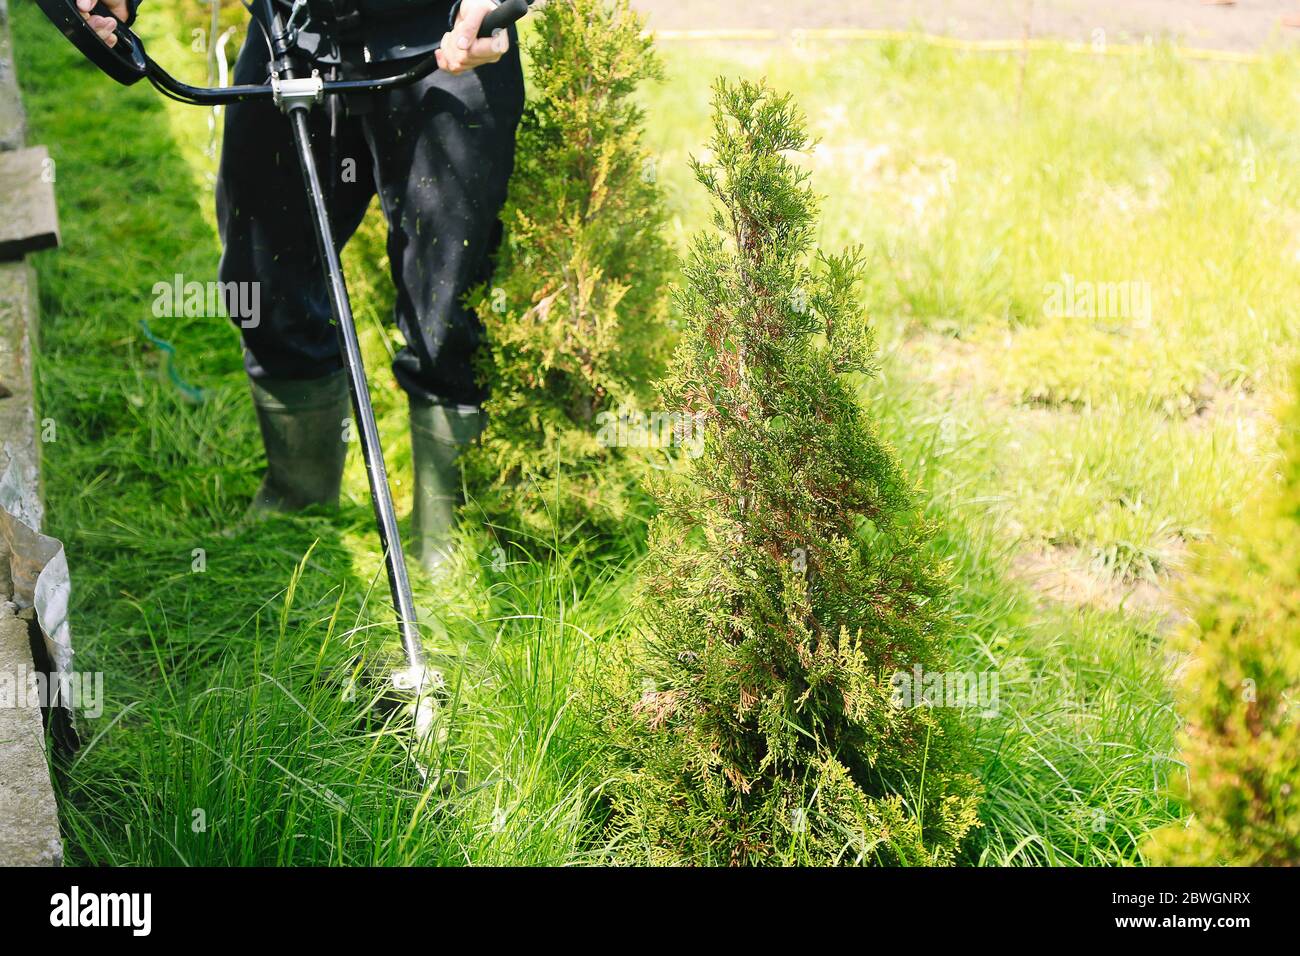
(1147, 387, 1300, 866)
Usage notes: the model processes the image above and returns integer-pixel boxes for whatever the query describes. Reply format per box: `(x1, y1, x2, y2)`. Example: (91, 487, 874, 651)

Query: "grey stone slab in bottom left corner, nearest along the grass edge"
(0, 605, 64, 866)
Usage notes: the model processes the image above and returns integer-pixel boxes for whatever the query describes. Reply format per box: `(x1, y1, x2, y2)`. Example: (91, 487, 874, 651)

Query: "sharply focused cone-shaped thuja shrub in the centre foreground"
(603, 81, 978, 865)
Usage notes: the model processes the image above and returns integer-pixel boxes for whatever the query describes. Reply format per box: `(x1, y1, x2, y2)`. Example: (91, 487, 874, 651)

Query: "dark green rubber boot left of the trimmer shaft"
(248, 372, 351, 518)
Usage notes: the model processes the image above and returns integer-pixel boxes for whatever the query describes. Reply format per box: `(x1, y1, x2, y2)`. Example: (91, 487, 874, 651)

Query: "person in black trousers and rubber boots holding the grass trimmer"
(77, 0, 524, 572)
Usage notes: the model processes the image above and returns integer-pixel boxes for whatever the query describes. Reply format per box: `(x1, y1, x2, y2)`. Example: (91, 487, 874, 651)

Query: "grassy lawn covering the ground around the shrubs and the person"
(14, 0, 1300, 865)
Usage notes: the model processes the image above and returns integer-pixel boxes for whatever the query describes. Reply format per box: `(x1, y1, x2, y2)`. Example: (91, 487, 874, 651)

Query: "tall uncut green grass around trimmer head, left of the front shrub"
(60, 541, 629, 866)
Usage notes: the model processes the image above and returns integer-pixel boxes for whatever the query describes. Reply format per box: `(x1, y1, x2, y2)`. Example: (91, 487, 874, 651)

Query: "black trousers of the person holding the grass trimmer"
(217, 29, 524, 405)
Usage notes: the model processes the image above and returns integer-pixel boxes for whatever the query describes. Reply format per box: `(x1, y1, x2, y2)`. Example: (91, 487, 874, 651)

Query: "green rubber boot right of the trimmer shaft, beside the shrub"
(411, 398, 486, 575)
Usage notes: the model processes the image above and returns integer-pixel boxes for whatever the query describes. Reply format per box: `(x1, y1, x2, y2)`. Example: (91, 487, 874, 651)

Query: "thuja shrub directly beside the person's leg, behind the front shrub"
(467, 0, 671, 536)
